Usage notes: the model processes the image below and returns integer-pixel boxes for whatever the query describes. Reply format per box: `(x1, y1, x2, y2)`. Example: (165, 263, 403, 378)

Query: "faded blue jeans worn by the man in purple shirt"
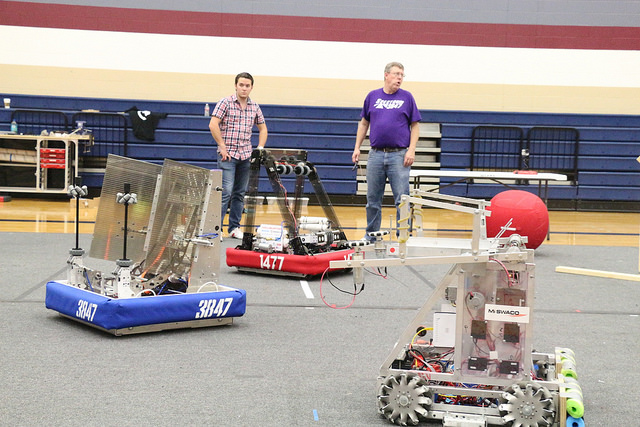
(365, 149, 411, 239)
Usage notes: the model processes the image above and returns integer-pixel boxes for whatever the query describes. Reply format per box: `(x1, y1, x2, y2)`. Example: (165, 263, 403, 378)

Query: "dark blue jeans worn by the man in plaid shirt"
(218, 155, 251, 232)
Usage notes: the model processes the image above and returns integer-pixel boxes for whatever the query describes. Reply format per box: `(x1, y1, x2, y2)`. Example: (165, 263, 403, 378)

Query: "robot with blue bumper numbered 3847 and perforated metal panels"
(45, 155, 246, 336)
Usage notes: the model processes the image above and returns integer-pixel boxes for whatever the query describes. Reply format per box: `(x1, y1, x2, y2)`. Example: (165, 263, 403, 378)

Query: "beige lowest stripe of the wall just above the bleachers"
(0, 65, 640, 114)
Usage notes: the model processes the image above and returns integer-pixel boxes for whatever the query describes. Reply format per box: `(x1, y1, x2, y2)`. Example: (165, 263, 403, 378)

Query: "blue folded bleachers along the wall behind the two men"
(0, 94, 640, 207)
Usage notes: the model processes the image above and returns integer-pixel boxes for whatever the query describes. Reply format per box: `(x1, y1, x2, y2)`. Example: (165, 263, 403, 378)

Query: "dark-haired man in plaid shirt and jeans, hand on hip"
(209, 73, 267, 239)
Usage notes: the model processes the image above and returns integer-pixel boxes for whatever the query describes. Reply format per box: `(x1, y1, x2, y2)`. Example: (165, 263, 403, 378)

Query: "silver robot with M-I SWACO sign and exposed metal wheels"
(331, 190, 584, 427)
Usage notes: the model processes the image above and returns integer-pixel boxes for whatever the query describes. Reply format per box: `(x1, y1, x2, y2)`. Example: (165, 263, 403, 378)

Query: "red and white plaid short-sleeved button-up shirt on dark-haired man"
(211, 94, 264, 160)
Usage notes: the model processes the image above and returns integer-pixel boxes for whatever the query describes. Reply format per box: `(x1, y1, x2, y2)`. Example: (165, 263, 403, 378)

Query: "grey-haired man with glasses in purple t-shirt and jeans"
(352, 62, 422, 240)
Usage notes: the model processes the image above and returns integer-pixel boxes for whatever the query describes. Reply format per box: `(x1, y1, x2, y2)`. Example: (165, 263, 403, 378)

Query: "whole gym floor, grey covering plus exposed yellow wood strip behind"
(0, 199, 640, 426)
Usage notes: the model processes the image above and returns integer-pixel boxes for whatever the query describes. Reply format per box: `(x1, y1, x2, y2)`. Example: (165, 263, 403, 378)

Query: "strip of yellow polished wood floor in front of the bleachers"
(0, 199, 640, 247)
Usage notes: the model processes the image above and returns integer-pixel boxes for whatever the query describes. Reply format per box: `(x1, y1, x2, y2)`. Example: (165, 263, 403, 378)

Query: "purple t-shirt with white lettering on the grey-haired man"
(360, 88, 422, 148)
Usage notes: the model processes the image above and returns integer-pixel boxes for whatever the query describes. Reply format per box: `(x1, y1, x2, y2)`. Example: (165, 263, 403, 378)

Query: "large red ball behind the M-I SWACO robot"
(487, 190, 549, 249)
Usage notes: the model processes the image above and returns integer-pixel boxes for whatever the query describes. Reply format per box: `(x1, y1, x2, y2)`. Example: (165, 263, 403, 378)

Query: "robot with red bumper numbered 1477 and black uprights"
(226, 149, 354, 277)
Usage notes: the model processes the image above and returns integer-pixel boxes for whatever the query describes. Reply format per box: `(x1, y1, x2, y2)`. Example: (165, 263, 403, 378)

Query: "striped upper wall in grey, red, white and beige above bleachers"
(0, 0, 640, 114)
